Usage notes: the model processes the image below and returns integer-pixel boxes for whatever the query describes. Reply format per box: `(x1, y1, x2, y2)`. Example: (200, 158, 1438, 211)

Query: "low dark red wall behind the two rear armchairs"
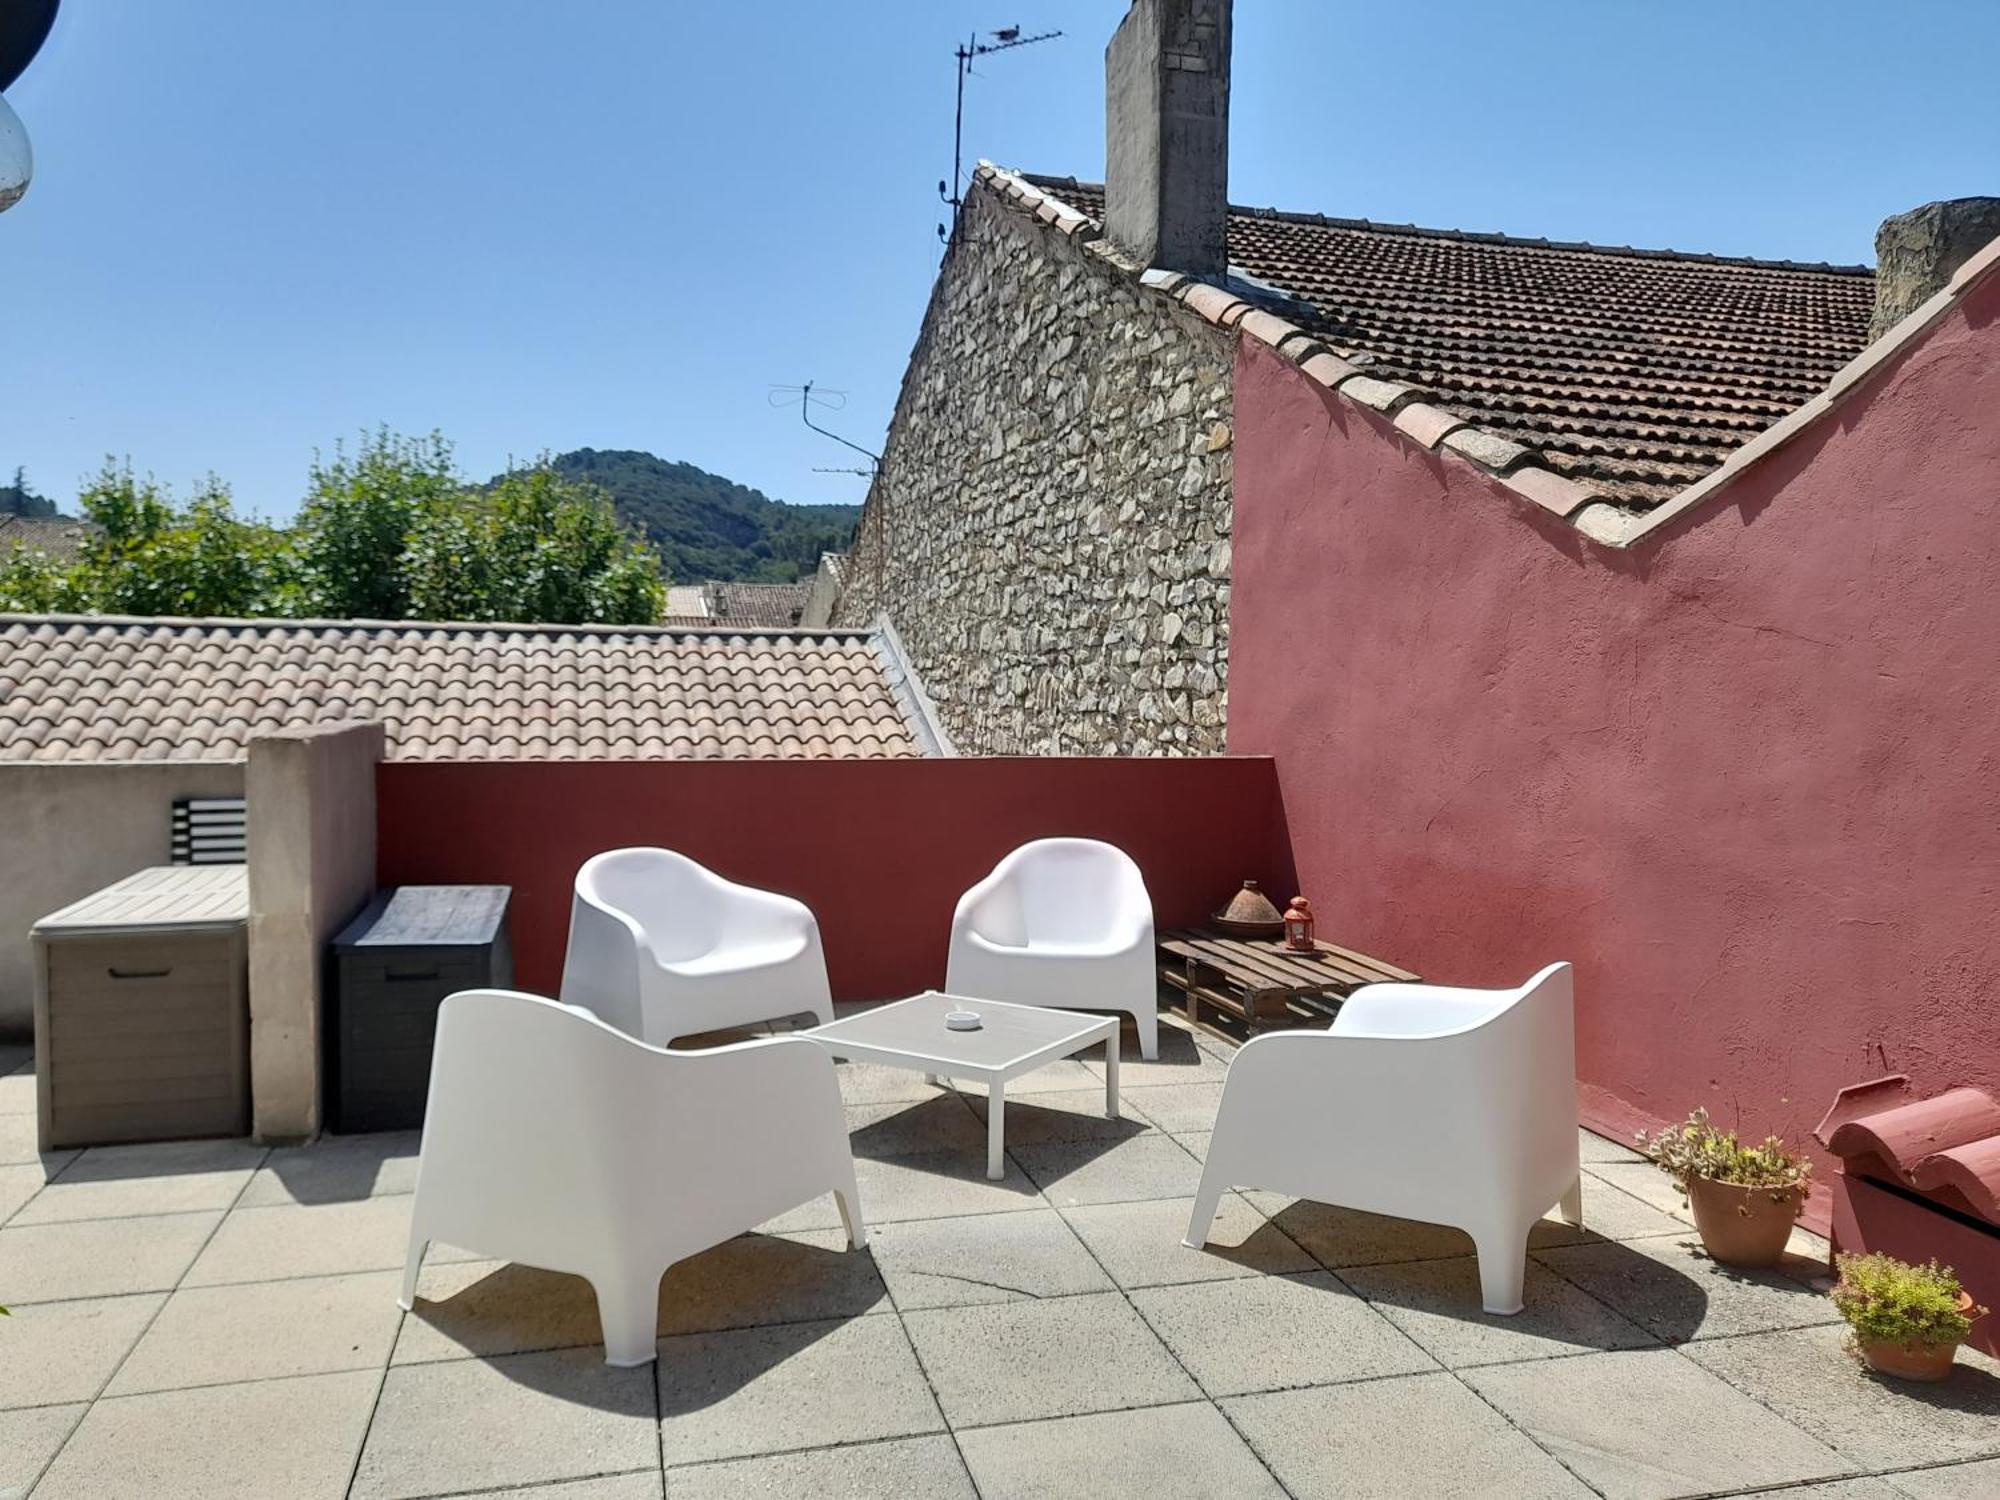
(376, 758, 1290, 1000)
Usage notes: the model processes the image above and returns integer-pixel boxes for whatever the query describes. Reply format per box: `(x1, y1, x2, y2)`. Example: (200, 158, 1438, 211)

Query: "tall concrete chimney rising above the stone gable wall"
(1104, 0, 1230, 276)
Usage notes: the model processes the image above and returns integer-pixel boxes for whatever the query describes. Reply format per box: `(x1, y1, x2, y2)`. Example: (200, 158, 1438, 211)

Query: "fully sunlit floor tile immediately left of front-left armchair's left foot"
(106, 1272, 402, 1396)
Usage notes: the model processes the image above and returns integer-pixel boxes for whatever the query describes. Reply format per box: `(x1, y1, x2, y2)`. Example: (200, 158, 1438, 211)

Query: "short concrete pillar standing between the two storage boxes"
(244, 724, 384, 1142)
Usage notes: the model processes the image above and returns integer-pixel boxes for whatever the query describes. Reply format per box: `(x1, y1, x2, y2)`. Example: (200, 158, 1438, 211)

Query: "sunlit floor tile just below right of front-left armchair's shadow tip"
(904, 1292, 1200, 1428)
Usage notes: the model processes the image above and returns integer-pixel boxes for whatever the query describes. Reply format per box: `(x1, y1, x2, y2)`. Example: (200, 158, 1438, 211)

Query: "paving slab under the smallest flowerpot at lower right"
(1682, 1326, 2000, 1468)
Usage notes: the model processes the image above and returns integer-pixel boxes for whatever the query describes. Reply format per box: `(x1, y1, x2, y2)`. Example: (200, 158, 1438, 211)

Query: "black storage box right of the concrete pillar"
(326, 886, 514, 1134)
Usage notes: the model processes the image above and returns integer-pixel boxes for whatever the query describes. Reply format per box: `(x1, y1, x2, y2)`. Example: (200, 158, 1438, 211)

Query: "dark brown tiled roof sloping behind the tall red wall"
(1024, 176, 1874, 512)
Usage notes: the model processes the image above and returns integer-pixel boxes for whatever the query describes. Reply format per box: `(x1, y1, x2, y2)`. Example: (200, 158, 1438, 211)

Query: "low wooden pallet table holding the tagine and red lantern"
(1158, 926, 1416, 1030)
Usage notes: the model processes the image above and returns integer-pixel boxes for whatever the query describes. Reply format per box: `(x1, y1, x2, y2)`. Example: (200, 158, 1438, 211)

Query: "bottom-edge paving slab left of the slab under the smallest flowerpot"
(1466, 1350, 1854, 1500)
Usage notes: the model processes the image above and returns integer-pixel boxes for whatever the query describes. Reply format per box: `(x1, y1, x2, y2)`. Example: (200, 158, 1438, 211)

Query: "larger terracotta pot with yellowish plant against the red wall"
(1638, 1110, 1812, 1266)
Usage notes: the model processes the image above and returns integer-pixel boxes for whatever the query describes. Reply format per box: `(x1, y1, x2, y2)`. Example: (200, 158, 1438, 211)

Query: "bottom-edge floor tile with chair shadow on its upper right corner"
(350, 1348, 658, 1500)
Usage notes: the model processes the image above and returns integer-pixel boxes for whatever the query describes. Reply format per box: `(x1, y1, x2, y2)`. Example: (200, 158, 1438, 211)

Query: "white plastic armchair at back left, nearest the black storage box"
(562, 848, 834, 1046)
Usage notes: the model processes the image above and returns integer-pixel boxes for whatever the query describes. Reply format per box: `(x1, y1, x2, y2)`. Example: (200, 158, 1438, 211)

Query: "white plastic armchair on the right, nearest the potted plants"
(1186, 964, 1582, 1314)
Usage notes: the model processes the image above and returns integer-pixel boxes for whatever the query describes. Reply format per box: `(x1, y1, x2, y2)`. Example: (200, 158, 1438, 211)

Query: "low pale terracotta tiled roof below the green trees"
(0, 614, 938, 762)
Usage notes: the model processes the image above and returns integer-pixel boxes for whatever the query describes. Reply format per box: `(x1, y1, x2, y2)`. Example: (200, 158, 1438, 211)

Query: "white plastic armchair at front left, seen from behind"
(398, 990, 868, 1366)
